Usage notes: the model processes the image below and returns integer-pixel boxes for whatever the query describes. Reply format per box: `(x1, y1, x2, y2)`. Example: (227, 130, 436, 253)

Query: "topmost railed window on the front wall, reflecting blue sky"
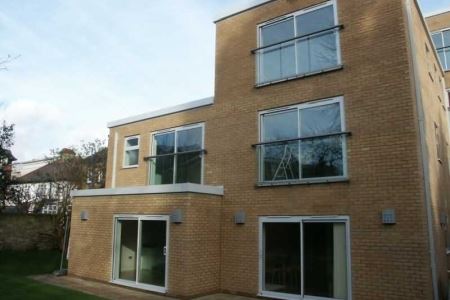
(255, 1, 341, 85)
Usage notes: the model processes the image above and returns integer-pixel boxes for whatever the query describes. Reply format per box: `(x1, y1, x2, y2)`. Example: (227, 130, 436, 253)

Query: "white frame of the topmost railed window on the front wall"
(255, 0, 342, 86)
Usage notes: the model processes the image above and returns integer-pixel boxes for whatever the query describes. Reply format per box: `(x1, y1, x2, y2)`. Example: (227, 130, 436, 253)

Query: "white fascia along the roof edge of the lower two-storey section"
(108, 97, 214, 128)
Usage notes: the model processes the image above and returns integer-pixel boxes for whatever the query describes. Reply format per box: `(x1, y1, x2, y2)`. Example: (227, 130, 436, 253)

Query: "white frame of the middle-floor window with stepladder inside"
(258, 96, 348, 186)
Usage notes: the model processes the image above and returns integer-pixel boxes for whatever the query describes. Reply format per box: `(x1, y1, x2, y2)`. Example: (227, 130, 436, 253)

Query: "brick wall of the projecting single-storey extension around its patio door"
(69, 193, 221, 296)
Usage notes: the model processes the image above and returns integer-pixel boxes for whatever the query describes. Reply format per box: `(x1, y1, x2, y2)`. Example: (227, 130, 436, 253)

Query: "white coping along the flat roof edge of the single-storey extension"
(70, 183, 223, 197)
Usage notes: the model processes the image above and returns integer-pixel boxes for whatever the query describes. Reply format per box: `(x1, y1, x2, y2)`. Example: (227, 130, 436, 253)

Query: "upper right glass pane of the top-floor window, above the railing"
(295, 5, 335, 36)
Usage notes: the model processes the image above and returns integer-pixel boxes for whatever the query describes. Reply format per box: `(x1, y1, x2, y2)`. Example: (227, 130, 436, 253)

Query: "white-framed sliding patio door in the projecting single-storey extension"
(113, 216, 168, 292)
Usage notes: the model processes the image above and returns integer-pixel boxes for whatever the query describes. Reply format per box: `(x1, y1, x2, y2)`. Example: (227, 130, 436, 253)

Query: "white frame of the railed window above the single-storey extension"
(148, 122, 205, 185)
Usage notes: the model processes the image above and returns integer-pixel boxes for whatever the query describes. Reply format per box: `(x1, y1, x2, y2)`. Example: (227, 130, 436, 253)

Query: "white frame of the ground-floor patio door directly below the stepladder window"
(258, 216, 352, 300)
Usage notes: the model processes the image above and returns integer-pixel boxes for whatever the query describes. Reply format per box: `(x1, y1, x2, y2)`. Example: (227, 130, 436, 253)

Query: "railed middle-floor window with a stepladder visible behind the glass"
(258, 97, 347, 184)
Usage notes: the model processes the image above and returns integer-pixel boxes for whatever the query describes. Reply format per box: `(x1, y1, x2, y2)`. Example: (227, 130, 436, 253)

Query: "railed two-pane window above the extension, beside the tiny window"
(149, 124, 205, 184)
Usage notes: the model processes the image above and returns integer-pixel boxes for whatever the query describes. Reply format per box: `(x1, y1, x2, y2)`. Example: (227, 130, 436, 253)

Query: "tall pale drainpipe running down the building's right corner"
(405, 0, 439, 300)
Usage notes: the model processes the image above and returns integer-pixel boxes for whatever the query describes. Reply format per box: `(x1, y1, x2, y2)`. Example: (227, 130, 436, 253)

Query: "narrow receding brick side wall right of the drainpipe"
(412, 2, 450, 298)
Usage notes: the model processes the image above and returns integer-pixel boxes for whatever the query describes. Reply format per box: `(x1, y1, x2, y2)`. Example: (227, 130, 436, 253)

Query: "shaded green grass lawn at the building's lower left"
(0, 251, 101, 300)
